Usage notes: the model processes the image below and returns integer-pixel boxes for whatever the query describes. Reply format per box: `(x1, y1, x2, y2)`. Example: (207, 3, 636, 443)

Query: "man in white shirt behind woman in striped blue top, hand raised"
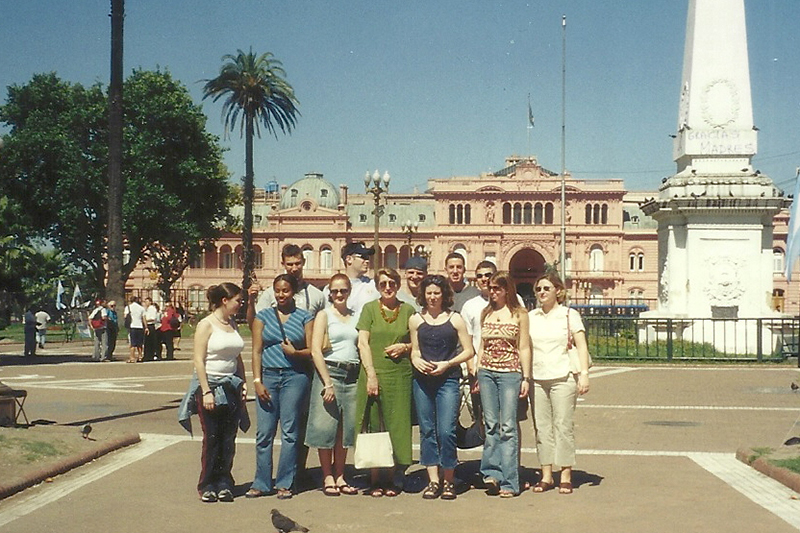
(247, 244, 325, 328)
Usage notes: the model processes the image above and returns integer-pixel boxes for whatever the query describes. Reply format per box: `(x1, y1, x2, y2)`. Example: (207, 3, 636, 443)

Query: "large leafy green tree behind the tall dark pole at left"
(0, 70, 228, 293)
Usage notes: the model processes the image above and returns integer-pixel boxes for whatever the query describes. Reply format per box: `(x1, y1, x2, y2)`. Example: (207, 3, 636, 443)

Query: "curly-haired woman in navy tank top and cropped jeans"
(409, 275, 474, 500)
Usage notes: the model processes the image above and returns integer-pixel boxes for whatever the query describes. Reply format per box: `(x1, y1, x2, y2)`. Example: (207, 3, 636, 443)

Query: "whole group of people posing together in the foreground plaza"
(181, 243, 589, 502)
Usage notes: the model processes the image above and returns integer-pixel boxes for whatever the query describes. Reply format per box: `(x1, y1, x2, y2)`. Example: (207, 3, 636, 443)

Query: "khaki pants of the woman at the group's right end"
(533, 374, 578, 467)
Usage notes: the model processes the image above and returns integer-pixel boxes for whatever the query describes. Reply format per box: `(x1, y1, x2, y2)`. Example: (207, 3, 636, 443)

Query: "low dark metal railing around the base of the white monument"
(583, 315, 800, 364)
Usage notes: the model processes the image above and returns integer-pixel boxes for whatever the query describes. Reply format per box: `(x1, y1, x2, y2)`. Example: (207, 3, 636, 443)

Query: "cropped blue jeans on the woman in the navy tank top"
(412, 376, 461, 470)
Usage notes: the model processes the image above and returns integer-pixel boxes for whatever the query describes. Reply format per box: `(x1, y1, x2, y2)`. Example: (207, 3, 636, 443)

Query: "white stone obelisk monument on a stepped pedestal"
(640, 0, 790, 353)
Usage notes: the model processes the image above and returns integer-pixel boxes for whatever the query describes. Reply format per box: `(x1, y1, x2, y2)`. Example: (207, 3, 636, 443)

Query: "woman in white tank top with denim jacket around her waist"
(178, 283, 250, 503)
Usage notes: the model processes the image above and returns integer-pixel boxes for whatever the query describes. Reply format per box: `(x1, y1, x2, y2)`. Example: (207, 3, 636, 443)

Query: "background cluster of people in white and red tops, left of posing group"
(124, 296, 186, 363)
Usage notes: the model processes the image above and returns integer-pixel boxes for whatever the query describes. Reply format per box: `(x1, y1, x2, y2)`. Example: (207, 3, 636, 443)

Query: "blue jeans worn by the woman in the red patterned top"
(478, 369, 522, 494)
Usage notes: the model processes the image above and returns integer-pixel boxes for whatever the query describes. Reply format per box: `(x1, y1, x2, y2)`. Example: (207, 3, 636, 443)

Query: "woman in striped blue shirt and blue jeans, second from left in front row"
(245, 274, 314, 499)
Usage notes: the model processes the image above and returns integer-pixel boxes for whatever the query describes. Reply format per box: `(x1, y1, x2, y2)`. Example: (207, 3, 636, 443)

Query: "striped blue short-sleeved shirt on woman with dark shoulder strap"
(256, 307, 314, 372)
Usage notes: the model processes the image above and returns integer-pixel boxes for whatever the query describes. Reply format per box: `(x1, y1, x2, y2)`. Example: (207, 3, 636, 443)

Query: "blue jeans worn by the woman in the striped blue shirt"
(251, 368, 310, 492)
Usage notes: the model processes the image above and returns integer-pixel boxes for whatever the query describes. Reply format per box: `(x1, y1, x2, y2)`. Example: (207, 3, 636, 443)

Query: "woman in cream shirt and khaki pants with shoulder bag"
(530, 274, 589, 494)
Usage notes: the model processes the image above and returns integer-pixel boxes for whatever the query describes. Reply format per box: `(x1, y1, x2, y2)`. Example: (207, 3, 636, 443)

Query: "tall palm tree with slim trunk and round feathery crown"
(203, 48, 300, 295)
